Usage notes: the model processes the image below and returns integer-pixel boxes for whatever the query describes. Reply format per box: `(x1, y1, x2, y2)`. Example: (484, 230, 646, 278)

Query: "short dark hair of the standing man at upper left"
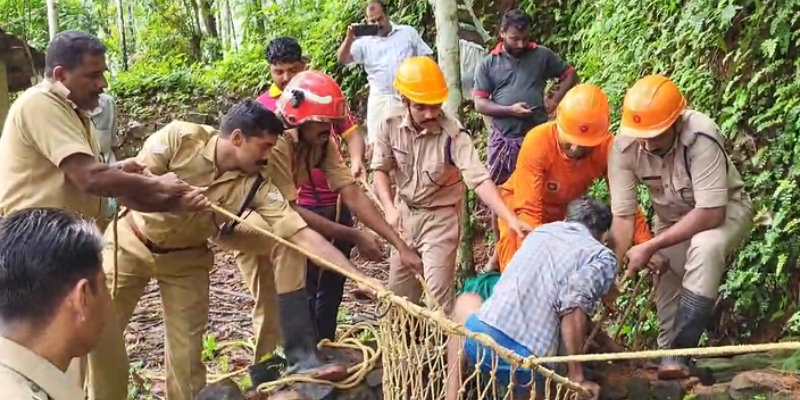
(44, 31, 106, 78)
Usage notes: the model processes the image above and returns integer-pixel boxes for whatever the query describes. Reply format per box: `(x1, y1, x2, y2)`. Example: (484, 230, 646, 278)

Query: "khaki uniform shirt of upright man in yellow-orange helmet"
(370, 108, 489, 208)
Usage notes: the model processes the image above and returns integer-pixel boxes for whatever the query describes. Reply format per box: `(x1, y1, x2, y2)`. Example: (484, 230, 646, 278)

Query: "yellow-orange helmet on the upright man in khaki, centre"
(394, 57, 450, 104)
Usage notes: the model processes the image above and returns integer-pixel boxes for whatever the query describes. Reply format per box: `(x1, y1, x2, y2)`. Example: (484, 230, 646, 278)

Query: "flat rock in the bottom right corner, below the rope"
(728, 370, 800, 400)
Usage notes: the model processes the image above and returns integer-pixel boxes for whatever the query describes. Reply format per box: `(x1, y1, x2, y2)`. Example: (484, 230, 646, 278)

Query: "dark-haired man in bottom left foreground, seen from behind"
(0, 208, 110, 400)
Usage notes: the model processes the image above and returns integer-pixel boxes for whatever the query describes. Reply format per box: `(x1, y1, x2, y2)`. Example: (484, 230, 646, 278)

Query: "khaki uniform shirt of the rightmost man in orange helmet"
(608, 110, 750, 231)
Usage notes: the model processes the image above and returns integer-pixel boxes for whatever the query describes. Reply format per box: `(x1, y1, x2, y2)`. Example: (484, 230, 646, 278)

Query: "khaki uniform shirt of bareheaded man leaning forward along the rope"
(133, 121, 307, 249)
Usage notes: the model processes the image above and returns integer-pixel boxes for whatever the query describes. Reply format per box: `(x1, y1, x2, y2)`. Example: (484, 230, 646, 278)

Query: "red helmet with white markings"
(275, 71, 346, 126)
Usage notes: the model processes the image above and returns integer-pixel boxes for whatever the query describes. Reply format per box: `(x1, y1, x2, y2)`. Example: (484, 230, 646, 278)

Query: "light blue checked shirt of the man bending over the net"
(477, 222, 617, 357)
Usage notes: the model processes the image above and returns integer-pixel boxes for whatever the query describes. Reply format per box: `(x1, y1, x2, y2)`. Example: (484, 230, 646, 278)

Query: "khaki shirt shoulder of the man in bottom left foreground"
(0, 337, 86, 400)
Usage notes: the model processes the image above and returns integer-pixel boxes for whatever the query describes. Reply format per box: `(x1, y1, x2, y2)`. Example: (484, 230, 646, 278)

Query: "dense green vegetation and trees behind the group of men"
(0, 0, 800, 342)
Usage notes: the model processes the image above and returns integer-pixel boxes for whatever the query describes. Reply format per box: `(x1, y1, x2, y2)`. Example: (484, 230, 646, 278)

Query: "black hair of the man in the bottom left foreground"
(0, 208, 103, 325)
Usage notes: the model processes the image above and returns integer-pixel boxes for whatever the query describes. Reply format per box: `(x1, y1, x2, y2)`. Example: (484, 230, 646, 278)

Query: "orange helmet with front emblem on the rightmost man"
(619, 75, 686, 139)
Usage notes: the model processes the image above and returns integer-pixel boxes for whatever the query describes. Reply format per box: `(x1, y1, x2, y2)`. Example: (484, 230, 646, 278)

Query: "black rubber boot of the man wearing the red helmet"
(278, 289, 347, 400)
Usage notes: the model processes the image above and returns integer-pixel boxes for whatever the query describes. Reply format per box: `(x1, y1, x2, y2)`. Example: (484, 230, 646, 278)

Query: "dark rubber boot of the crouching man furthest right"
(658, 289, 715, 380)
